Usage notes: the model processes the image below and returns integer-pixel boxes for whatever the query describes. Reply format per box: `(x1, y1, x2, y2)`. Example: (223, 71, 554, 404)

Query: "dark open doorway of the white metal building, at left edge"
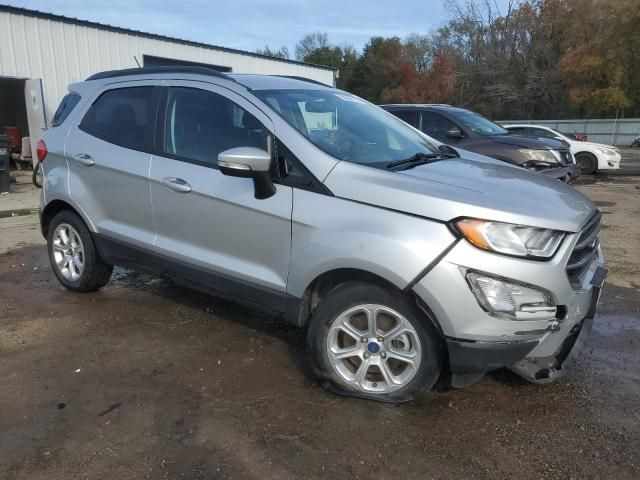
(0, 77, 46, 168)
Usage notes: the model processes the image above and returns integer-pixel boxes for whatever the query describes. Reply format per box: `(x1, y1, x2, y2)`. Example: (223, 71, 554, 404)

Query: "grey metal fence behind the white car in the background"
(498, 118, 640, 147)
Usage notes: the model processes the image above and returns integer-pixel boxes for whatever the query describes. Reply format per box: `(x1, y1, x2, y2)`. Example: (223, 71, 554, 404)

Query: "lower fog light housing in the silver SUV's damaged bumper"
(467, 272, 556, 320)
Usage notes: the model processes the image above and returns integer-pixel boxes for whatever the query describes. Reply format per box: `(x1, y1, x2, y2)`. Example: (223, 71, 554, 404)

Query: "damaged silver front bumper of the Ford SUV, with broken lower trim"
(413, 212, 607, 387)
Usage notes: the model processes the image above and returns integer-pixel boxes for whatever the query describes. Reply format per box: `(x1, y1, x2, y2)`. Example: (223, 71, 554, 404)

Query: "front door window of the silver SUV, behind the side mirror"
(163, 87, 269, 167)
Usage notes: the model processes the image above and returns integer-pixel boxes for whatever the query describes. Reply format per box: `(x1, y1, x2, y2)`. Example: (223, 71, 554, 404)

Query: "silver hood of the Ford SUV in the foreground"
(324, 156, 596, 232)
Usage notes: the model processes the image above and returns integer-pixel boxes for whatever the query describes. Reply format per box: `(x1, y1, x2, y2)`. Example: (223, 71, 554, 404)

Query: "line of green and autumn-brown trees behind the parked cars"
(259, 0, 640, 119)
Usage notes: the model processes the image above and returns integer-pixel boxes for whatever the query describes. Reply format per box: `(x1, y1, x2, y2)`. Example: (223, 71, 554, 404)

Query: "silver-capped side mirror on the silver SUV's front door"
(218, 147, 276, 199)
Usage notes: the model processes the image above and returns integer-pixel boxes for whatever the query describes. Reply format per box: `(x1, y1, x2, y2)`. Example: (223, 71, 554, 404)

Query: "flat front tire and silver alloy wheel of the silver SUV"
(307, 282, 443, 402)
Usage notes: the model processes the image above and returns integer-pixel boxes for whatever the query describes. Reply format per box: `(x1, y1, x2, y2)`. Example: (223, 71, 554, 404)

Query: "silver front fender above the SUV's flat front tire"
(287, 189, 456, 298)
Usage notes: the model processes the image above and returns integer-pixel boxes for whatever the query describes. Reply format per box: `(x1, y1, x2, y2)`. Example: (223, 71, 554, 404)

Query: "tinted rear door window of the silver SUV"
(80, 87, 158, 151)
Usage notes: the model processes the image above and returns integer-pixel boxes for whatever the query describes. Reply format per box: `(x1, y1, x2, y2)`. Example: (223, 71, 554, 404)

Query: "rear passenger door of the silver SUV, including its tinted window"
(65, 81, 160, 248)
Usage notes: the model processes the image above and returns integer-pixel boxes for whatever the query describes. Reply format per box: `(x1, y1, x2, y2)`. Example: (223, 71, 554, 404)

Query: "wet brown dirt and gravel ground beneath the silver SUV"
(0, 171, 640, 480)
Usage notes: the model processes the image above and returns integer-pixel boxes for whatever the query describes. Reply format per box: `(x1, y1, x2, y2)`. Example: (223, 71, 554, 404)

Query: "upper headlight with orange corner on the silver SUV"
(455, 218, 564, 259)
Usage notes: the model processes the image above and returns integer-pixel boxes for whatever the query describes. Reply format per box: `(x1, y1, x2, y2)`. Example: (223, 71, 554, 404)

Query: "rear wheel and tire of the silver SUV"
(47, 210, 113, 292)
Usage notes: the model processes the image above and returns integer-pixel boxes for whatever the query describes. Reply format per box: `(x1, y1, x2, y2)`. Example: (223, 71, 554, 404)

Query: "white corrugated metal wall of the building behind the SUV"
(0, 11, 334, 119)
